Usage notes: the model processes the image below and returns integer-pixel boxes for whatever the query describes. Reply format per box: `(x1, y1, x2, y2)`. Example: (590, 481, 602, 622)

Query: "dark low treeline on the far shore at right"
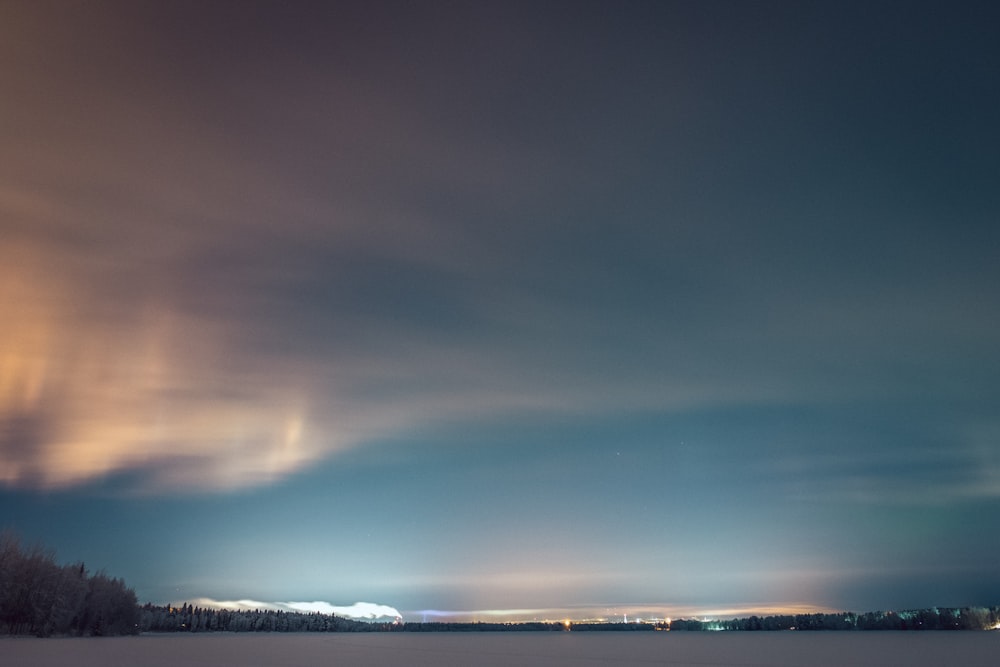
(669, 607, 1000, 631)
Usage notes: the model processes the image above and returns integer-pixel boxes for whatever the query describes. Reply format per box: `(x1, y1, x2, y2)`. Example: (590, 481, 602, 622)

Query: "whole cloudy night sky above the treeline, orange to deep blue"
(0, 0, 1000, 620)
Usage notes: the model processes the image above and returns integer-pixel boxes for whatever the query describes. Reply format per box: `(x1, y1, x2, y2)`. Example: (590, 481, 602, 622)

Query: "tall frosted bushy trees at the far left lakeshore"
(0, 533, 139, 637)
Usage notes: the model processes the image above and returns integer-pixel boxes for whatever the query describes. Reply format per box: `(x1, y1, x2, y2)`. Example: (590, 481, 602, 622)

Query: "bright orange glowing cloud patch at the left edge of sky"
(0, 235, 334, 489)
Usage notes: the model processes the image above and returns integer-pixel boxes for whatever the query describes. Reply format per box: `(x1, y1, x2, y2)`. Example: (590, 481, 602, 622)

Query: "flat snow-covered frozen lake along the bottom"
(0, 632, 1000, 667)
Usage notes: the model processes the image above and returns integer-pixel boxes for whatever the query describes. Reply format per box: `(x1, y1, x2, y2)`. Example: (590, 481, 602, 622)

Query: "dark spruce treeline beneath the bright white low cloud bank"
(139, 603, 384, 632)
